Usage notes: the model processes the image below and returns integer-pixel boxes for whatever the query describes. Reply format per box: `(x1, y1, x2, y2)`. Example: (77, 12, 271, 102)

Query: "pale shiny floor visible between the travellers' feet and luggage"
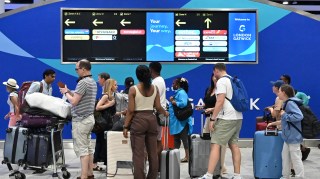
(0, 148, 320, 179)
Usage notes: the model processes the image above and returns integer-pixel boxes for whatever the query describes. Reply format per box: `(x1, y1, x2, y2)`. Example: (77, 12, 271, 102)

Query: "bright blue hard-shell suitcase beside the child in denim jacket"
(252, 129, 283, 179)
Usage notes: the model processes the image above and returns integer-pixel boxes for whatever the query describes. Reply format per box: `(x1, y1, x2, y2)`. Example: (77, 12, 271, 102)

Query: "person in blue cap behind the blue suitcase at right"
(267, 80, 284, 121)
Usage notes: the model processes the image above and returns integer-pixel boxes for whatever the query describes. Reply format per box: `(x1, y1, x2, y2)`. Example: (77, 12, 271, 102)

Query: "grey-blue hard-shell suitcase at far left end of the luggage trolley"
(3, 127, 28, 165)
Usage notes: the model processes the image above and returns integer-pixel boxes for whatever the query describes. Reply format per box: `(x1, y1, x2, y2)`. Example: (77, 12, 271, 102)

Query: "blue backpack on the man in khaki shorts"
(224, 76, 250, 112)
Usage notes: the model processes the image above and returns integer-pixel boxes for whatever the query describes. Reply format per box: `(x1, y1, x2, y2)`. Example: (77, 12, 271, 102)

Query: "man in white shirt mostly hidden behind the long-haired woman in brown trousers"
(149, 62, 167, 171)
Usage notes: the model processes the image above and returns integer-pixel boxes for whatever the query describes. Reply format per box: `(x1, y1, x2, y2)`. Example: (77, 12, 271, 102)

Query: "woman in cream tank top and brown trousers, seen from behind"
(123, 65, 169, 179)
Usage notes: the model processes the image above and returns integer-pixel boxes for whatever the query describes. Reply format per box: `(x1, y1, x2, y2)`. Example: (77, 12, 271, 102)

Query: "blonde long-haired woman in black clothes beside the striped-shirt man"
(93, 79, 118, 171)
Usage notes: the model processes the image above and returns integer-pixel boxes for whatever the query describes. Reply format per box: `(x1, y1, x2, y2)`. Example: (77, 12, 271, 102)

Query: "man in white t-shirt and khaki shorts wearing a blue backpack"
(200, 63, 243, 179)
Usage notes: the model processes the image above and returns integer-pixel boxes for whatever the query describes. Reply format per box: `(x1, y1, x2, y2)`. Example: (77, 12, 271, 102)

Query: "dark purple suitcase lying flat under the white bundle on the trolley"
(21, 113, 58, 128)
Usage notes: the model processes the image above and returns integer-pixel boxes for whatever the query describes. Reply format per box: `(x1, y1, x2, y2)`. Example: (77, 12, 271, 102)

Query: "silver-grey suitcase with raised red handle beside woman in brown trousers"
(160, 117, 180, 179)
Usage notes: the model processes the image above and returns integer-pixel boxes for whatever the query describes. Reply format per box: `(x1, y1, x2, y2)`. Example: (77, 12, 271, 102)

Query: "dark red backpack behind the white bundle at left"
(18, 81, 43, 114)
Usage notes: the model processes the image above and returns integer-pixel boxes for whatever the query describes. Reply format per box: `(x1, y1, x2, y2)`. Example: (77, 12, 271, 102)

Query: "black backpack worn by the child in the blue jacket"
(283, 99, 320, 139)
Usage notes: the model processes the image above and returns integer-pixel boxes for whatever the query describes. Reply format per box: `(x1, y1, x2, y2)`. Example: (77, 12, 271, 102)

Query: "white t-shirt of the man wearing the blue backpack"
(216, 77, 243, 120)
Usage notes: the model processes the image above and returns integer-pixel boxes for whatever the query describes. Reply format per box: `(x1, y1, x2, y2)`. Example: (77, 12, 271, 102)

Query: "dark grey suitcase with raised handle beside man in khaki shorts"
(188, 113, 221, 178)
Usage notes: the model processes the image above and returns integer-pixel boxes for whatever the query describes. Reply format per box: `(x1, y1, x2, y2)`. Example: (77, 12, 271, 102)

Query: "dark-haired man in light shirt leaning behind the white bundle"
(27, 69, 56, 96)
